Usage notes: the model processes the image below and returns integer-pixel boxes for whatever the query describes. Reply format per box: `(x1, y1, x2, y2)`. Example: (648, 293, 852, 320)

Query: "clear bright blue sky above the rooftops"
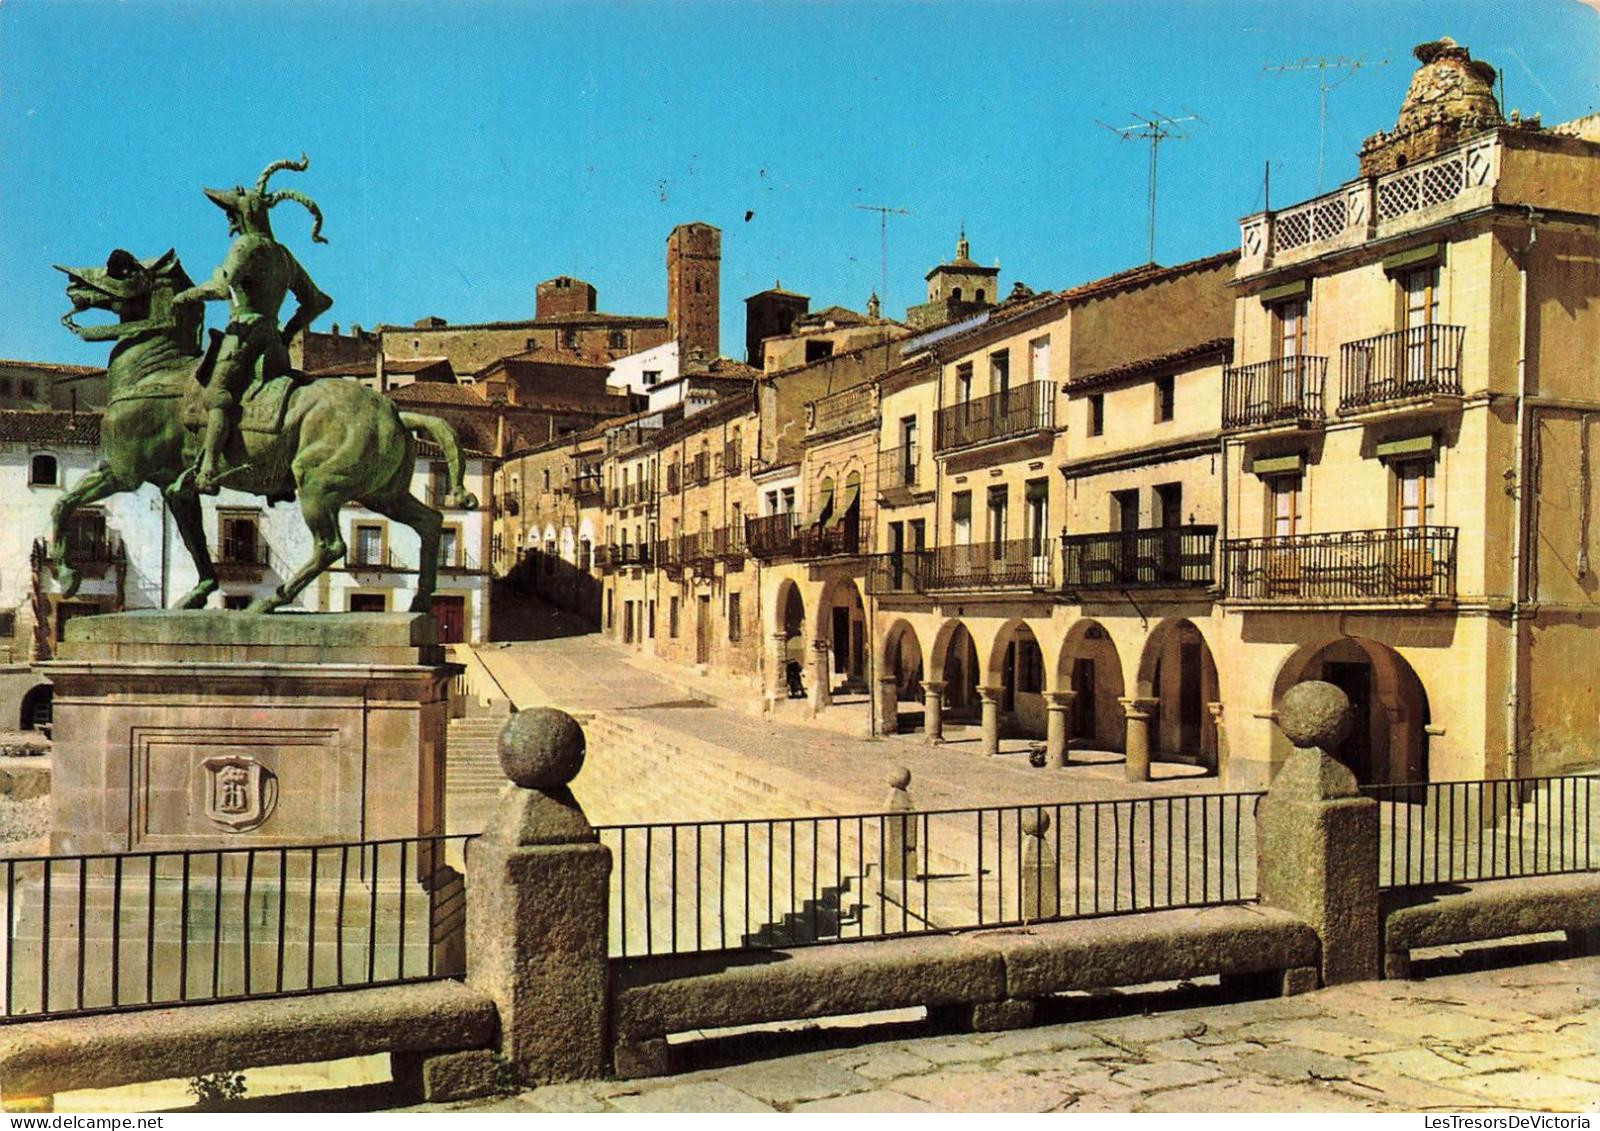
(0, 0, 1600, 363)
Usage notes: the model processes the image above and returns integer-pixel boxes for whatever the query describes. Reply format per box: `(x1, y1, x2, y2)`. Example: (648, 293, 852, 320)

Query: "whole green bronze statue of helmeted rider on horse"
(50, 158, 477, 613)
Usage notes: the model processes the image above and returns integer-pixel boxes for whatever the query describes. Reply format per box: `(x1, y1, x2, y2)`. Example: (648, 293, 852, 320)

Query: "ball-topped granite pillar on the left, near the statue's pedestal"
(467, 709, 611, 1085)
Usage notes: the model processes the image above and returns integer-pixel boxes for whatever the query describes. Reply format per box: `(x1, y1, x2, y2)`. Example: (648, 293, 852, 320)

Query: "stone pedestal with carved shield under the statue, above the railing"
(42, 609, 458, 853)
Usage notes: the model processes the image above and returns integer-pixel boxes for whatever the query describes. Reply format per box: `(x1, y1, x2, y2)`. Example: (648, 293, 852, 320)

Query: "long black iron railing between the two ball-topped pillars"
(598, 793, 1261, 957)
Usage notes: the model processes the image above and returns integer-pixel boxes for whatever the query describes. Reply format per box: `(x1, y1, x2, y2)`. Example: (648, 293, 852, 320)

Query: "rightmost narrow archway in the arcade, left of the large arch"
(1139, 619, 1222, 773)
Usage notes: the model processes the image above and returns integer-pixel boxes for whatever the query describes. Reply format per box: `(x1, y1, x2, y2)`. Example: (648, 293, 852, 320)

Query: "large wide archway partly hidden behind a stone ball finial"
(1272, 637, 1432, 785)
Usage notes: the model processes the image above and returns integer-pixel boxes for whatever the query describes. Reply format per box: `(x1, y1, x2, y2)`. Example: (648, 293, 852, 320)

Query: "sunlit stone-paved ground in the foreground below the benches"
(427, 958, 1600, 1112)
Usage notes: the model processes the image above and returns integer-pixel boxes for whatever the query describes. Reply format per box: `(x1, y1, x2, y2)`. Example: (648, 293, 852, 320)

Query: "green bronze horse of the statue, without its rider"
(50, 250, 477, 613)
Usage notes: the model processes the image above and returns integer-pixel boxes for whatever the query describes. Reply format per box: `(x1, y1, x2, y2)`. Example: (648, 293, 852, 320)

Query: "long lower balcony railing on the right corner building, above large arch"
(1222, 526, 1456, 601)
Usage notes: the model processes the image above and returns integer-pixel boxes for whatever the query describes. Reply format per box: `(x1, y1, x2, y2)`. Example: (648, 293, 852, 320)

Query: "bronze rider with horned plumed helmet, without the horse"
(168, 154, 333, 494)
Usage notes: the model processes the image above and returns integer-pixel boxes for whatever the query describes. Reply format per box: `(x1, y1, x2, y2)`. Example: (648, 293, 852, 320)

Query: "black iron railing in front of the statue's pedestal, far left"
(0, 835, 469, 1024)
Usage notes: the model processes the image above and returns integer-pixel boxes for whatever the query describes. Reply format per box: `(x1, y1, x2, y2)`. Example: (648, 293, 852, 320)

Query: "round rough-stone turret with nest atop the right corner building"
(1362, 35, 1506, 176)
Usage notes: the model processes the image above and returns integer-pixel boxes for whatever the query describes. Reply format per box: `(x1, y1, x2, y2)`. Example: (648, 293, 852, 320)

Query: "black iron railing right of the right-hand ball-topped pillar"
(1363, 774, 1600, 888)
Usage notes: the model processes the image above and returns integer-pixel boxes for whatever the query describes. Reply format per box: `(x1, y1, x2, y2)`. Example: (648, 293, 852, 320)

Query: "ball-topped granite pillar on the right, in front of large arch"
(1256, 680, 1379, 985)
